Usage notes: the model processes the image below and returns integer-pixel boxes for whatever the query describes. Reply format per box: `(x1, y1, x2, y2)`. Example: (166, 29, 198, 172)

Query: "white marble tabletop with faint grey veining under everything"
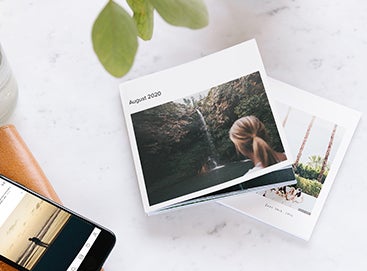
(0, 0, 367, 271)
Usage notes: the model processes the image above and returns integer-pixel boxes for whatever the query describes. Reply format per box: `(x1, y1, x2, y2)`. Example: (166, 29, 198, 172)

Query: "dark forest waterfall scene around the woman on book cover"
(131, 72, 286, 205)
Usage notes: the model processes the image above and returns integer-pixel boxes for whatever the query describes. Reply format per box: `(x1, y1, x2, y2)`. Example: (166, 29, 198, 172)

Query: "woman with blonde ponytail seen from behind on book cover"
(229, 116, 287, 171)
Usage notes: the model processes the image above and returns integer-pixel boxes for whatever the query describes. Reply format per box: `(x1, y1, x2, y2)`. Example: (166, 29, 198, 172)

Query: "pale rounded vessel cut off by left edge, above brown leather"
(0, 45, 18, 125)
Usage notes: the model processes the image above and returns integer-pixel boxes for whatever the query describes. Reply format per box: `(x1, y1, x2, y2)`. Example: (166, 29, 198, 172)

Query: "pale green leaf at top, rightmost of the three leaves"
(149, 0, 208, 29)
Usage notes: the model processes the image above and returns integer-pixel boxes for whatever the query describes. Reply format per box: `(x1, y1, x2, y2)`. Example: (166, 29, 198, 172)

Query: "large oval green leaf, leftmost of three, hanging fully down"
(92, 0, 138, 77)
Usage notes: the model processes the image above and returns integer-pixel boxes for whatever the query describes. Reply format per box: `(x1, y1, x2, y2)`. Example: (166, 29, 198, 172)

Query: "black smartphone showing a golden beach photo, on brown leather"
(0, 175, 116, 271)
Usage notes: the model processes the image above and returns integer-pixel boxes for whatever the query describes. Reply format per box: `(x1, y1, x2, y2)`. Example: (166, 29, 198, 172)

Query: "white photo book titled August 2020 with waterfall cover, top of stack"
(120, 40, 295, 214)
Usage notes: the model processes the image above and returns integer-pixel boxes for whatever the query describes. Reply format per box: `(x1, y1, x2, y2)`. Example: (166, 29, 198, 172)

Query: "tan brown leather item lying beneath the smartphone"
(0, 125, 103, 271)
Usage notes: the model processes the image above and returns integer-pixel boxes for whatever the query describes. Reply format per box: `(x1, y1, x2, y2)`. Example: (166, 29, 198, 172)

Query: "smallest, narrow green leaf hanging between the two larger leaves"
(127, 0, 154, 40)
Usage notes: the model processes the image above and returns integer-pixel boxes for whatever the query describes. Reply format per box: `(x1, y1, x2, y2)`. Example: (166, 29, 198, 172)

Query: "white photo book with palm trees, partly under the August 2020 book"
(219, 79, 361, 240)
